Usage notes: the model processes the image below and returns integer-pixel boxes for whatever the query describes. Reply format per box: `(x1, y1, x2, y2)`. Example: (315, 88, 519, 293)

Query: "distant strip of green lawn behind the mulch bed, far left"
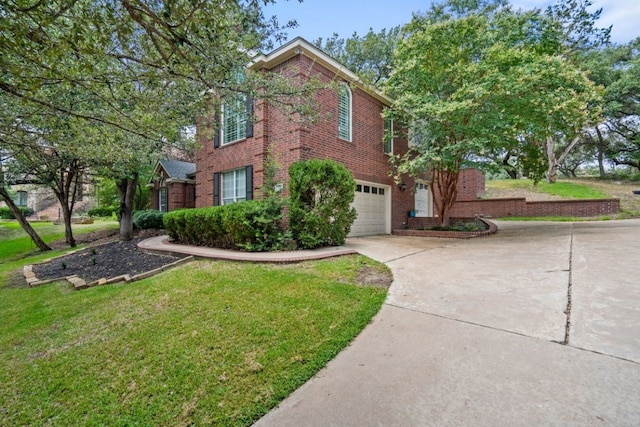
(0, 220, 118, 264)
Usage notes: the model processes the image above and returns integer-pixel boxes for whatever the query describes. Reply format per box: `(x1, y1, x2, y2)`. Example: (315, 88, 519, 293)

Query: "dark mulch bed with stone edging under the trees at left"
(33, 238, 188, 282)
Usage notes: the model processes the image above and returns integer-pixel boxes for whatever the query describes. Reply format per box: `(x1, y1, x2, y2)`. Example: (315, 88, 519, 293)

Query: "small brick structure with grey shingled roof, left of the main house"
(149, 159, 196, 212)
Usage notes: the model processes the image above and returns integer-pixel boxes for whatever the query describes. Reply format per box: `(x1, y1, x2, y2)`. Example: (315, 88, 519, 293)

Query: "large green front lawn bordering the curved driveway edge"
(0, 255, 389, 426)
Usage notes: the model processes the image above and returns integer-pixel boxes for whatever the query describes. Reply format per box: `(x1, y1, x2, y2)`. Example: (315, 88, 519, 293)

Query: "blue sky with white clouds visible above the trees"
(265, 0, 640, 44)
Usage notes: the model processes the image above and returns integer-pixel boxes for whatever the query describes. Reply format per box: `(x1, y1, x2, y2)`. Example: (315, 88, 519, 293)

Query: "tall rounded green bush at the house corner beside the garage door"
(289, 159, 357, 249)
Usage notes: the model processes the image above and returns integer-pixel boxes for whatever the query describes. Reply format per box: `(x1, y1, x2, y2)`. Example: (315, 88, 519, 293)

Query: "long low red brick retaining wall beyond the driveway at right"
(451, 198, 620, 218)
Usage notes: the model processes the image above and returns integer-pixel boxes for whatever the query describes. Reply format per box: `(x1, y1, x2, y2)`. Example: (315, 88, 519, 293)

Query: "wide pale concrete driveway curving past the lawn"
(256, 220, 640, 426)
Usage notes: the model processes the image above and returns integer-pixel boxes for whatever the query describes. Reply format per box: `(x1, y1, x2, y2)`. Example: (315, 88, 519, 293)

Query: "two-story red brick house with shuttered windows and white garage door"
(195, 38, 484, 236)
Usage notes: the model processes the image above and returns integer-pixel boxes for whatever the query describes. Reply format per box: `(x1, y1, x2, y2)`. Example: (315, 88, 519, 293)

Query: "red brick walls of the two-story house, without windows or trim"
(196, 49, 484, 229)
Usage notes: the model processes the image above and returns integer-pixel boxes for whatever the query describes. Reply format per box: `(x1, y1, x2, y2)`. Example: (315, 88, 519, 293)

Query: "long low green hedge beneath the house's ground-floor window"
(164, 198, 287, 252)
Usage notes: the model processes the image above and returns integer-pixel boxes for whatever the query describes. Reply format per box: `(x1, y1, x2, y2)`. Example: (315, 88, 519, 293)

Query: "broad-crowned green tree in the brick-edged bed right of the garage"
(386, 0, 598, 225)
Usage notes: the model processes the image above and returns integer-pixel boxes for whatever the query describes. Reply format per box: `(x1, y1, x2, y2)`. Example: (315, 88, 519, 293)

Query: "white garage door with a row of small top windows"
(349, 181, 391, 237)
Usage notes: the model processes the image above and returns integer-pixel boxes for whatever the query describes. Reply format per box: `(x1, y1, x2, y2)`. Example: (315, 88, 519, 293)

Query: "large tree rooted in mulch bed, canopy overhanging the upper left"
(0, 0, 306, 239)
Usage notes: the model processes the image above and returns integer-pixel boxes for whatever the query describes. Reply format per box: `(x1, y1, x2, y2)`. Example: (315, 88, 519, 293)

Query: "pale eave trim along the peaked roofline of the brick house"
(248, 37, 393, 106)
